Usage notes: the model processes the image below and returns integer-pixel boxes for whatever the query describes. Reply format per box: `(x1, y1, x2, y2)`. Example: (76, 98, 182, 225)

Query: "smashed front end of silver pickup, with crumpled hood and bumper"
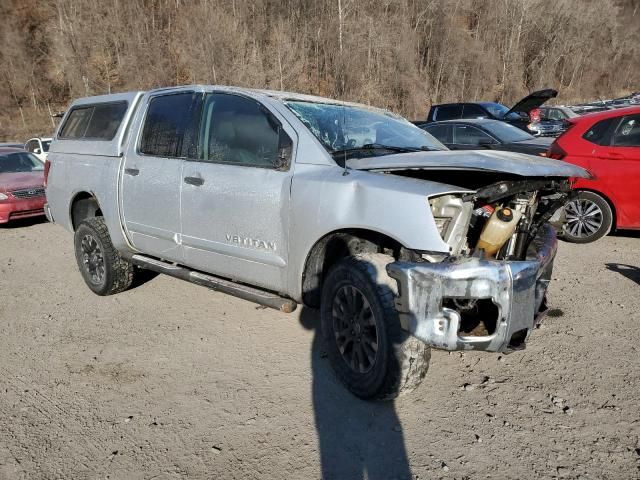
(350, 152, 589, 352)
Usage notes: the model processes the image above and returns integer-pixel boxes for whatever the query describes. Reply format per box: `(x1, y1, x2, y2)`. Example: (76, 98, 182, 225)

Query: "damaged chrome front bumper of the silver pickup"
(387, 224, 557, 352)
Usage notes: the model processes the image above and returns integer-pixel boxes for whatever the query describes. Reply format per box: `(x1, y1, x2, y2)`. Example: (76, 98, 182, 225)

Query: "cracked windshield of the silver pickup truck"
(286, 100, 447, 157)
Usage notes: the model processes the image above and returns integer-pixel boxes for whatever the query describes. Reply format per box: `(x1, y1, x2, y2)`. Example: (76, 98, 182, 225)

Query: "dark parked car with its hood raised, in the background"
(427, 88, 558, 132)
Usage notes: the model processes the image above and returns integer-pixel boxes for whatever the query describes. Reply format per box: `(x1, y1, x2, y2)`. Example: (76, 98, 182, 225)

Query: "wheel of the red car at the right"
(562, 191, 613, 243)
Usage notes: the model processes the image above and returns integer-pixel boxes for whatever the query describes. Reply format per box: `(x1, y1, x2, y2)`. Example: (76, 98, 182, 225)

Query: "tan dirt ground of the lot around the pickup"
(0, 218, 640, 479)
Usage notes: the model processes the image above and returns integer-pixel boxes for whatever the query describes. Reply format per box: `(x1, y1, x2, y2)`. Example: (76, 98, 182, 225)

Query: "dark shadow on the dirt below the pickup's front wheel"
(300, 307, 412, 480)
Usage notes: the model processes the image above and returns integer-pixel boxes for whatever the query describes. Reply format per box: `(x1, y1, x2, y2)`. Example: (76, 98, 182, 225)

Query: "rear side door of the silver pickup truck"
(120, 91, 202, 262)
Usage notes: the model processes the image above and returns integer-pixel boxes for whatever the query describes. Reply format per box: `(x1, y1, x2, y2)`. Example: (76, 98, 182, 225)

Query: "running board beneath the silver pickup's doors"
(131, 254, 298, 313)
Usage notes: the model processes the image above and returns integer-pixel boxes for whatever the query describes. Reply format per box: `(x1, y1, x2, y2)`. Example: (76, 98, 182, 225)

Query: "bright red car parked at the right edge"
(548, 107, 640, 243)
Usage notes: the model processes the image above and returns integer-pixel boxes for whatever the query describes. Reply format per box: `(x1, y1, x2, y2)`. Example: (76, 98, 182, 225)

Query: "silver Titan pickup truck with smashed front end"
(45, 86, 589, 399)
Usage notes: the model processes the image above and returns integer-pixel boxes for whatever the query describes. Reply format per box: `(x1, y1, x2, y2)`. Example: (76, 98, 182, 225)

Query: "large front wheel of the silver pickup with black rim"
(320, 253, 431, 400)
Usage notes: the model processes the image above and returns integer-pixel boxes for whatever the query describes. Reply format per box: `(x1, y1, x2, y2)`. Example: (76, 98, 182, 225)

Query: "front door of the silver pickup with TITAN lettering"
(181, 93, 295, 290)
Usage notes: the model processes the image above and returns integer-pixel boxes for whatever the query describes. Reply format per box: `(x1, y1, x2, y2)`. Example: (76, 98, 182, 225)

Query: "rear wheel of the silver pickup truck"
(74, 217, 134, 295)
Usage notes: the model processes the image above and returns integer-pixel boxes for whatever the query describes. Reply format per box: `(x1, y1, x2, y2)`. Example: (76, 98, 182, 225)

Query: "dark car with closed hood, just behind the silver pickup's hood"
(421, 119, 552, 156)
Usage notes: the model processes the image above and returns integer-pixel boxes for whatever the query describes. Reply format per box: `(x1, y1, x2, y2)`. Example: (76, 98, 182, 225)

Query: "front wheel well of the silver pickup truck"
(302, 229, 416, 308)
